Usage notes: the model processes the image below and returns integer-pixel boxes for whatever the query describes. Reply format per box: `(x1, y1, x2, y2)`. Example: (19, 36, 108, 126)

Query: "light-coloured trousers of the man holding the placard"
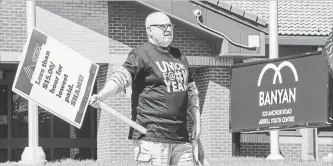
(133, 140, 194, 166)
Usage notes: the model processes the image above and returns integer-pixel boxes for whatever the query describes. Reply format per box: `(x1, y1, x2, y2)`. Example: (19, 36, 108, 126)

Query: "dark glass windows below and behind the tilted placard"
(0, 81, 97, 162)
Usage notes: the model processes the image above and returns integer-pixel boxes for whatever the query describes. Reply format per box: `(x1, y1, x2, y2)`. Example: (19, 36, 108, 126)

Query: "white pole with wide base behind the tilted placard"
(21, 0, 46, 165)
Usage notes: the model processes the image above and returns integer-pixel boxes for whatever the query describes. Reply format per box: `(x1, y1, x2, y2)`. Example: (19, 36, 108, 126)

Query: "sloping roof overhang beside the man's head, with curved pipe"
(132, 0, 268, 57)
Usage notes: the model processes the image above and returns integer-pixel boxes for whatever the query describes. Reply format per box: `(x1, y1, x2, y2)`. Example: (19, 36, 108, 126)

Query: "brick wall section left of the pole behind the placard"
(0, 0, 26, 52)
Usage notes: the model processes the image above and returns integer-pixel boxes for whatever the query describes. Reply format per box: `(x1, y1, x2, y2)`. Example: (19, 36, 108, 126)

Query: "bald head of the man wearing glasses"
(146, 12, 174, 47)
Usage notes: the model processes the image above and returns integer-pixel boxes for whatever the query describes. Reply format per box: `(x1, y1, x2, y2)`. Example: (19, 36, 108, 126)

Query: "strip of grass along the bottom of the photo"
(0, 157, 333, 166)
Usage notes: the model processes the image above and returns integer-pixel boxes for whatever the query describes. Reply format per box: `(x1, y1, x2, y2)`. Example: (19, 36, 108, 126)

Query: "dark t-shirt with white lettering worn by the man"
(123, 42, 193, 143)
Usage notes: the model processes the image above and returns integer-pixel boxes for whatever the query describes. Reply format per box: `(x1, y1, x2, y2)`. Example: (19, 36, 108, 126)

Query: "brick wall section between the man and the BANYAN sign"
(195, 67, 232, 158)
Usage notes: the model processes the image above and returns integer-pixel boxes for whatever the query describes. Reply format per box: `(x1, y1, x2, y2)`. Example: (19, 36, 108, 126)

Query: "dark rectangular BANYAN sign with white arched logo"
(230, 52, 332, 131)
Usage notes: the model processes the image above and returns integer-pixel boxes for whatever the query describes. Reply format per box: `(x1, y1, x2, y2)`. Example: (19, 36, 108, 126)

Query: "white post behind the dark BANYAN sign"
(267, 0, 284, 160)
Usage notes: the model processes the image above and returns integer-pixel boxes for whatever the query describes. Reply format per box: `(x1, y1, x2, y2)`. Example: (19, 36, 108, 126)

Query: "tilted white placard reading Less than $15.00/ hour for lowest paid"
(12, 29, 98, 128)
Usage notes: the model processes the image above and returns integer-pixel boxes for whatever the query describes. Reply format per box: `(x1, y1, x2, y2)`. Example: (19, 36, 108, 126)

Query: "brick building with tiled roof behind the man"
(0, 0, 333, 162)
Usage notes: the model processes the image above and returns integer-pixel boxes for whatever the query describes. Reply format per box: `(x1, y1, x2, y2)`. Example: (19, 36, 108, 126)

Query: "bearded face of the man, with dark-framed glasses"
(148, 17, 174, 47)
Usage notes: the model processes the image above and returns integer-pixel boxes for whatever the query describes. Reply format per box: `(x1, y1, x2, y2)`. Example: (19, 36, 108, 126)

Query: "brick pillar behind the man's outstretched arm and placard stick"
(97, 64, 134, 160)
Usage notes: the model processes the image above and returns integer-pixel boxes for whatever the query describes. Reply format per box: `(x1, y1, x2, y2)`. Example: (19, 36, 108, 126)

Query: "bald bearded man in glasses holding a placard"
(90, 12, 201, 165)
